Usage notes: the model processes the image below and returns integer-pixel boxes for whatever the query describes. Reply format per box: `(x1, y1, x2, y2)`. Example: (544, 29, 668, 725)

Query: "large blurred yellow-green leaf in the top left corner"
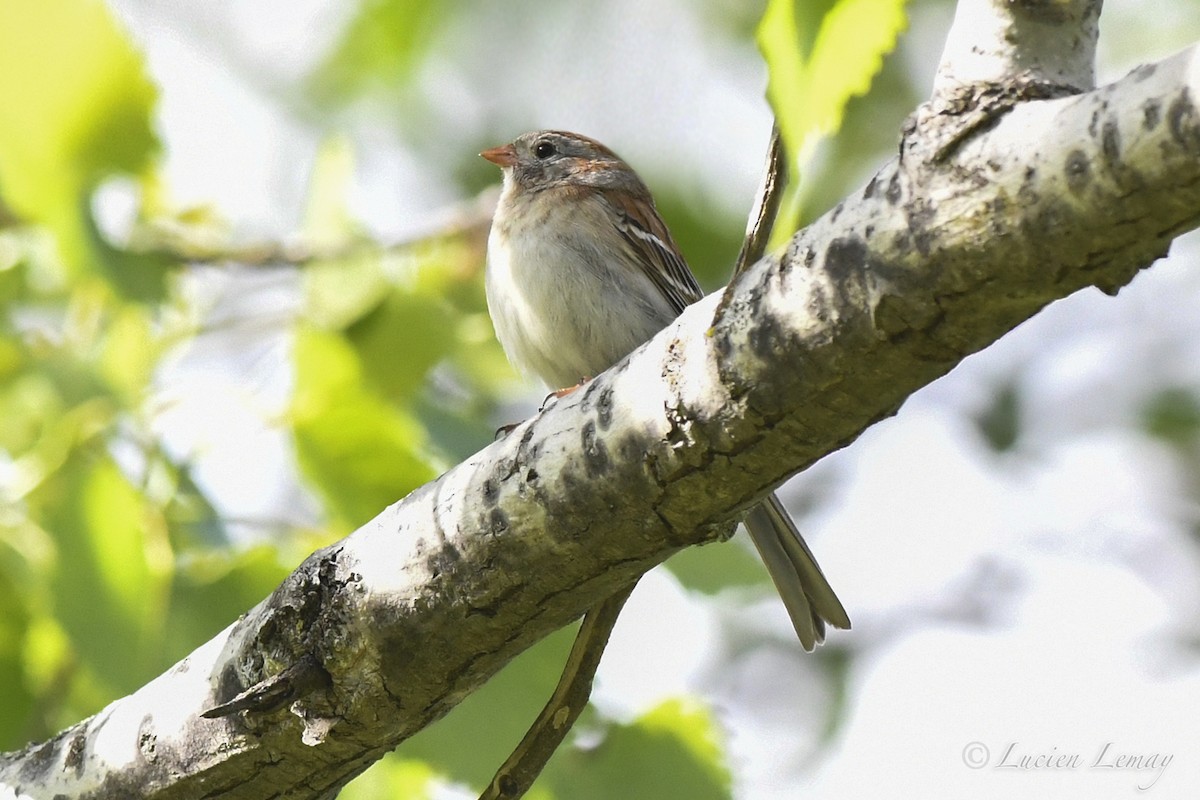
(0, 0, 164, 299)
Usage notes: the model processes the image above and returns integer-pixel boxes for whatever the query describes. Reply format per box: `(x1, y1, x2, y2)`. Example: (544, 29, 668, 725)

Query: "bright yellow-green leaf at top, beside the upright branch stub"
(758, 0, 906, 245)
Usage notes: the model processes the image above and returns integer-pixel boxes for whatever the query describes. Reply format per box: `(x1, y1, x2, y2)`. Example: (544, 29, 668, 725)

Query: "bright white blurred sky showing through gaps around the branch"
(106, 0, 1200, 800)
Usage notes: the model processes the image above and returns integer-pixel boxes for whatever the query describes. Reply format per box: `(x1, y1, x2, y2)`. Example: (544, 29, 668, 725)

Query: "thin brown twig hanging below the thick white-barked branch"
(479, 582, 637, 800)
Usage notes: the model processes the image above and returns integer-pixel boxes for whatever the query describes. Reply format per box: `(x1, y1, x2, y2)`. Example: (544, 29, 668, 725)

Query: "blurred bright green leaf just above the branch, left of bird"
(289, 326, 436, 527)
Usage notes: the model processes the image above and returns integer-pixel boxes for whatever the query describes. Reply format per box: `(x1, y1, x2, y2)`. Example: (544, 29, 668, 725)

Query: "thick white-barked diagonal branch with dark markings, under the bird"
(0, 2, 1200, 799)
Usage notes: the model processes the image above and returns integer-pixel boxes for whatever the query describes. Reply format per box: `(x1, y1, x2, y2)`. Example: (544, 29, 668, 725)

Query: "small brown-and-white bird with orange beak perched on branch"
(480, 131, 850, 650)
